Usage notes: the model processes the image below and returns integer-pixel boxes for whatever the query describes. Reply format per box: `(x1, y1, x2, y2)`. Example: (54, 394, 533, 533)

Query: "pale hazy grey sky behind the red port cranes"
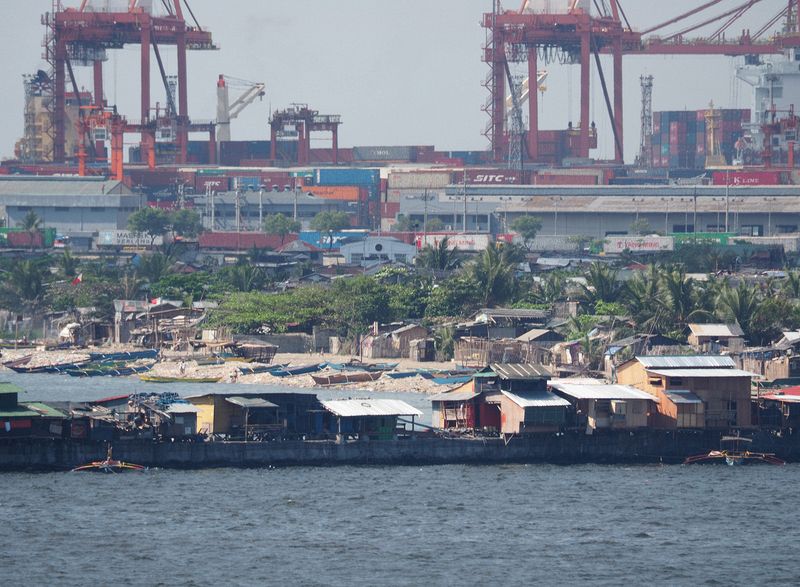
(0, 0, 785, 160)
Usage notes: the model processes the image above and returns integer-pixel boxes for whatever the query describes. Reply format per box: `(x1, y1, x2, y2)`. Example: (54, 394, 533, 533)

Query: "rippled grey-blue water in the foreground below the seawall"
(0, 465, 800, 585)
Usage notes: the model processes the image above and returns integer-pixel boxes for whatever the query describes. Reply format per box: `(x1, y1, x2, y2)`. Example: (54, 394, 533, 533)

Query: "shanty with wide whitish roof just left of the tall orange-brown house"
(549, 379, 658, 434)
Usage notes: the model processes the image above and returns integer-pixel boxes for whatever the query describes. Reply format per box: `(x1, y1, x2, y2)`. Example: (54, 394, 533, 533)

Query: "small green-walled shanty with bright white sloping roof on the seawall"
(322, 399, 422, 442)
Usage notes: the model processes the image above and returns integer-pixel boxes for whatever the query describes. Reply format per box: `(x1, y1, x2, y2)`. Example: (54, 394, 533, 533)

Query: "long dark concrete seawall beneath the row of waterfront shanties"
(0, 431, 800, 471)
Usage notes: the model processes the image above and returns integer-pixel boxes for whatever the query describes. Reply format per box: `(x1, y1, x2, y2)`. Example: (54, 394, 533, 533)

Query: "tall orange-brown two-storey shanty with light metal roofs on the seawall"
(617, 355, 752, 428)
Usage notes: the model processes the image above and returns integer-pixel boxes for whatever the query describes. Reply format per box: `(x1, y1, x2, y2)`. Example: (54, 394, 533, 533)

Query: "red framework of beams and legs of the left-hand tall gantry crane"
(53, 5, 216, 163)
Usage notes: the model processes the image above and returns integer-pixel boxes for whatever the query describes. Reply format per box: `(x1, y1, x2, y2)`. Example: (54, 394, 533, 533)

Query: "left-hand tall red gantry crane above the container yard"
(44, 0, 216, 163)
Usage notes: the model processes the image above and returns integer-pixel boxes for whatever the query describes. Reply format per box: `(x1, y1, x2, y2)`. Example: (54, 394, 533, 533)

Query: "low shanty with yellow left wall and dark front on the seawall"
(186, 391, 321, 438)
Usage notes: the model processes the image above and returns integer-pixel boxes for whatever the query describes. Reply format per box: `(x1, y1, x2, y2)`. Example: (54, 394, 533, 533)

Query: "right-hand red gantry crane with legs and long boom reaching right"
(483, 0, 800, 162)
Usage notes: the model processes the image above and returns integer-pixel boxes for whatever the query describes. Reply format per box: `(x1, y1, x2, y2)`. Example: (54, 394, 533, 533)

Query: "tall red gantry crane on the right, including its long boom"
(483, 0, 800, 162)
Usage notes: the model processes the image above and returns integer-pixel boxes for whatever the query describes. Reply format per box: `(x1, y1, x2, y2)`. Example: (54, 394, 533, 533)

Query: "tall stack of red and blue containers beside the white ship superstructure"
(651, 109, 750, 170)
